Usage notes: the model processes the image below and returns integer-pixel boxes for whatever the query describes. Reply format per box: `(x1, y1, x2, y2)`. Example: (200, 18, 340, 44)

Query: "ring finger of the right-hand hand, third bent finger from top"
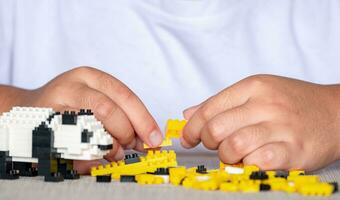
(218, 123, 284, 163)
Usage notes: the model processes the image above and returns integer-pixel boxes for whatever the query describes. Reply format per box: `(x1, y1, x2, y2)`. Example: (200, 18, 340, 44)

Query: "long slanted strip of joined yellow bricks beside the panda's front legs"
(91, 151, 177, 179)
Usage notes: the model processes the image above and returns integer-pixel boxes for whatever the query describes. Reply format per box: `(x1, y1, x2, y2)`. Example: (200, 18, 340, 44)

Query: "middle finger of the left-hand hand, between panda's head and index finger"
(64, 85, 135, 145)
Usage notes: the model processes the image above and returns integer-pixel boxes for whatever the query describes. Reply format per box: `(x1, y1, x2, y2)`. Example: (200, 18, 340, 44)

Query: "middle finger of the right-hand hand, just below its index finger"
(199, 102, 271, 149)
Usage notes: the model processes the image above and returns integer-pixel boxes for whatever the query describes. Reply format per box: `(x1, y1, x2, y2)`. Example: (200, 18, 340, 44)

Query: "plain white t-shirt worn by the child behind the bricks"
(0, 0, 340, 150)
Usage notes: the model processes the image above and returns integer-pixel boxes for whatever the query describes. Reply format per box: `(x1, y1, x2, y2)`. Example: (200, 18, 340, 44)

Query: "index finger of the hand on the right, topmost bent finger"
(182, 80, 251, 148)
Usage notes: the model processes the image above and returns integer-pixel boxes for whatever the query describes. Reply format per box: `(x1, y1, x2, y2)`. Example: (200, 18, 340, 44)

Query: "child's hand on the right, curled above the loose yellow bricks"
(181, 75, 340, 170)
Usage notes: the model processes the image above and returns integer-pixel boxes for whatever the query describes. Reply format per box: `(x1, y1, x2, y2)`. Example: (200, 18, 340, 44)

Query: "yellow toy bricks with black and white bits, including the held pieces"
(91, 120, 338, 196)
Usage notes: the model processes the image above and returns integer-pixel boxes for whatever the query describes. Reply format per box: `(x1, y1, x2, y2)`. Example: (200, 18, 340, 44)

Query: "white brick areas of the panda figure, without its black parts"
(0, 107, 112, 163)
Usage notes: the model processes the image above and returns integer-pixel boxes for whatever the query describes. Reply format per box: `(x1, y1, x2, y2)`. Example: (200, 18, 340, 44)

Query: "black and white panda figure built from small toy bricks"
(0, 107, 113, 182)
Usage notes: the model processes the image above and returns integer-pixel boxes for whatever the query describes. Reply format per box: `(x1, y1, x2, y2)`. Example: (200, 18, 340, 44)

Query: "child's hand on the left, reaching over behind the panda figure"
(2, 67, 162, 171)
